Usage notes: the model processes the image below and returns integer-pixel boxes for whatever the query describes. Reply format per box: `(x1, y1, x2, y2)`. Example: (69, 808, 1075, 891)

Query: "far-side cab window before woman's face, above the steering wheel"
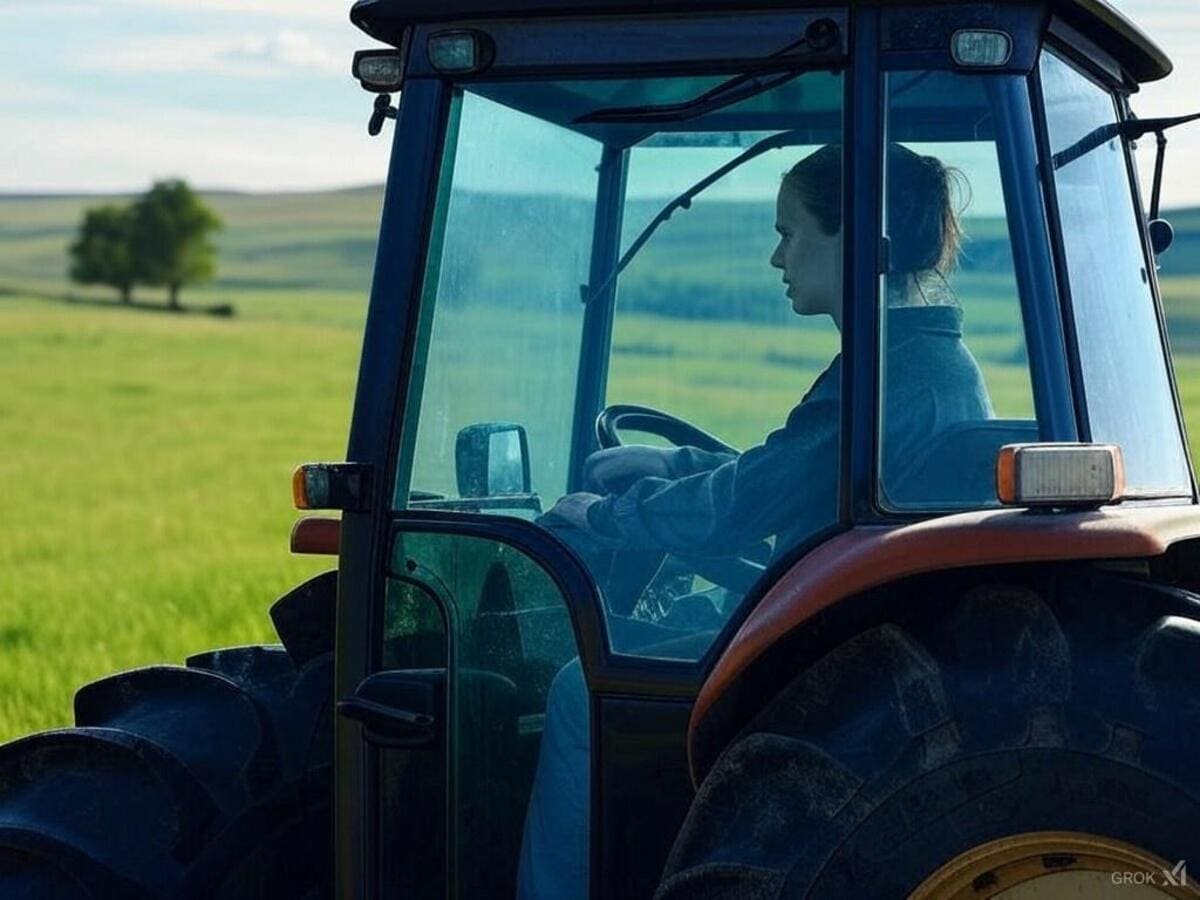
(607, 86, 841, 458)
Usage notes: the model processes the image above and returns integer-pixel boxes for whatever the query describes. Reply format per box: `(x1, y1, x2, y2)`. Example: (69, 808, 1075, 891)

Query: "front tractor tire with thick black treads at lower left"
(0, 572, 336, 900)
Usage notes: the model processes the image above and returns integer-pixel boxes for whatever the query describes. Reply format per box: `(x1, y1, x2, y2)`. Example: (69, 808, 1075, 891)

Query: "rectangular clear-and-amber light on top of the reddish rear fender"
(996, 444, 1126, 508)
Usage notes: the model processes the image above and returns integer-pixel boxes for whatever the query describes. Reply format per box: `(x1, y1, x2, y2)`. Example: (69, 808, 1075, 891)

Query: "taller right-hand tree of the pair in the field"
(132, 180, 221, 310)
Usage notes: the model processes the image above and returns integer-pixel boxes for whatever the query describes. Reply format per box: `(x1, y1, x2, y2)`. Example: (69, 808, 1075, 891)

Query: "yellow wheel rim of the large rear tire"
(910, 832, 1200, 900)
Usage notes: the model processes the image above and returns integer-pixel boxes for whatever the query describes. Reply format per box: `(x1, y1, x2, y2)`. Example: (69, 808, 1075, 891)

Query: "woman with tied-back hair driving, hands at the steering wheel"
(544, 144, 991, 578)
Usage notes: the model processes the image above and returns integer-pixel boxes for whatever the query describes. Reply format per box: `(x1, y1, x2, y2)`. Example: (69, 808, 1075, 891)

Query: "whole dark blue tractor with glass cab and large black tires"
(0, 0, 1200, 900)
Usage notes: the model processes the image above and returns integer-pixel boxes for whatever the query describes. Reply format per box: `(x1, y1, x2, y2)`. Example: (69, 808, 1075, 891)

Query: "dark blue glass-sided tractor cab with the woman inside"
(319, 0, 1194, 898)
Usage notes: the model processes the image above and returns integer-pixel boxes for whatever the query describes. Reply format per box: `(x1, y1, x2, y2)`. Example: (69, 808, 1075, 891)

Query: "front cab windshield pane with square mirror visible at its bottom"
(397, 92, 601, 516)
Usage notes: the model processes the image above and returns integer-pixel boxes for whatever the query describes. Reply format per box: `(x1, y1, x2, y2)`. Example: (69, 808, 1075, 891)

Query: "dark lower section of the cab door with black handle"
(352, 514, 598, 899)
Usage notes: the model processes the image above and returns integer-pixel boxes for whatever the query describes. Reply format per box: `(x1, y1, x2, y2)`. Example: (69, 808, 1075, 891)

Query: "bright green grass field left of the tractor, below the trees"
(0, 290, 361, 739)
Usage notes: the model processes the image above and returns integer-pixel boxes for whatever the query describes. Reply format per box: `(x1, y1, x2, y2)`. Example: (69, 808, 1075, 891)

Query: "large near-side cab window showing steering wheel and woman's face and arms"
(396, 72, 844, 660)
